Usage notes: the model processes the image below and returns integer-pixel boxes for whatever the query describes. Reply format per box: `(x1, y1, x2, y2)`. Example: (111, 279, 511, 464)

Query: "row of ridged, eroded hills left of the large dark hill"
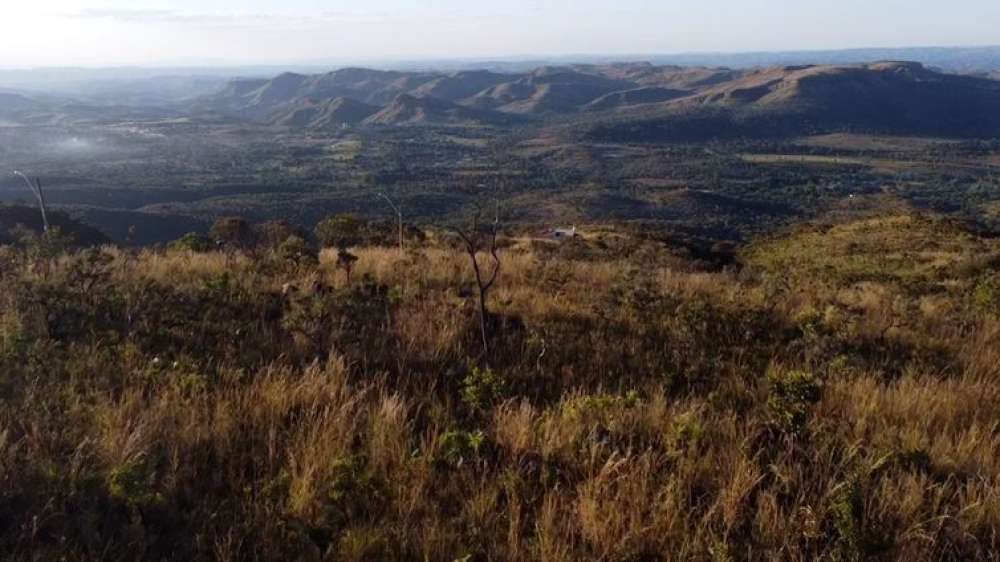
(196, 63, 744, 128)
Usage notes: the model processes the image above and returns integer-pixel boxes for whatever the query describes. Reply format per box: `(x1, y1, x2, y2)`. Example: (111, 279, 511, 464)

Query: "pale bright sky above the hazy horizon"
(0, 0, 1000, 68)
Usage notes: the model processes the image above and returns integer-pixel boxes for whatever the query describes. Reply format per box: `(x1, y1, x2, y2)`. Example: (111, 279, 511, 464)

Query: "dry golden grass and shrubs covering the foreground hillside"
(0, 209, 1000, 562)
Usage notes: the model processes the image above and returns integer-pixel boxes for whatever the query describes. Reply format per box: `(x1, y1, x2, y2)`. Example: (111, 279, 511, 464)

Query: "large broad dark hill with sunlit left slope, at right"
(591, 62, 1000, 139)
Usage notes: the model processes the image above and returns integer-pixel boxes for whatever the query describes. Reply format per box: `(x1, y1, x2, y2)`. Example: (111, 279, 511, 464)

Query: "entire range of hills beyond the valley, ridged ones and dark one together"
(195, 62, 1000, 139)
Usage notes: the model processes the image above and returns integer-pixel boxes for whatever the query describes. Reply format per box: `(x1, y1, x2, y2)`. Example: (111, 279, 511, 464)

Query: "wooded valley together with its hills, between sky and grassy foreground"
(0, 59, 1000, 244)
